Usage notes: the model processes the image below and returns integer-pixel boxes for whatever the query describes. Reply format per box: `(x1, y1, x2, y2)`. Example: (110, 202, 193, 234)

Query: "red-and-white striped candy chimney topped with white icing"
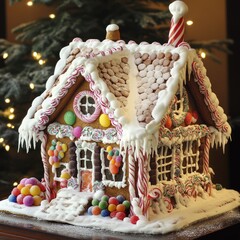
(168, 1, 188, 47)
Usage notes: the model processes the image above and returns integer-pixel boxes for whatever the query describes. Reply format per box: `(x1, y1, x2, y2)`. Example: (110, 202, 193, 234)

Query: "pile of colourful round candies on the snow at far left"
(8, 177, 46, 207)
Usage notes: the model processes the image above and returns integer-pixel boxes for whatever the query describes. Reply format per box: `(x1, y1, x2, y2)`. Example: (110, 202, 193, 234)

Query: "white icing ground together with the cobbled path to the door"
(0, 189, 240, 234)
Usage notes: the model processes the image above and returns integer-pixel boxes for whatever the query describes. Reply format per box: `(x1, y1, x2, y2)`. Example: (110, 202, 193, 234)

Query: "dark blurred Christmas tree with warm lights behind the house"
(0, 0, 232, 184)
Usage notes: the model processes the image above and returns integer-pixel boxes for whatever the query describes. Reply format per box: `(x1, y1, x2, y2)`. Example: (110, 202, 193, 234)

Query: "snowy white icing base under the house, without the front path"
(0, 189, 240, 234)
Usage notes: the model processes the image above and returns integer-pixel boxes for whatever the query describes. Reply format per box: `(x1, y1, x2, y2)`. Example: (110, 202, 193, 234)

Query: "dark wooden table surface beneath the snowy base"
(0, 208, 240, 240)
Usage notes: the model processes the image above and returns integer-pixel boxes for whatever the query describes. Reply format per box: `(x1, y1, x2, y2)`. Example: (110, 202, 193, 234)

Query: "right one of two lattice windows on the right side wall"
(181, 139, 201, 174)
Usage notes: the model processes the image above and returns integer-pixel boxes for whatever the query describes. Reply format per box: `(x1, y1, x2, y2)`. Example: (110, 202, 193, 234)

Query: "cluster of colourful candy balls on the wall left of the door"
(48, 139, 67, 168)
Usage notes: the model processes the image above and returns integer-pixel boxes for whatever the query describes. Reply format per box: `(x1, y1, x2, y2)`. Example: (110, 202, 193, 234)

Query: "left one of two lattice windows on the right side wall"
(156, 146, 173, 182)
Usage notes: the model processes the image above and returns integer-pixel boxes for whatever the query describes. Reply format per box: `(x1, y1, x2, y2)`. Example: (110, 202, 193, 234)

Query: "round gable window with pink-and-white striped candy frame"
(73, 91, 101, 123)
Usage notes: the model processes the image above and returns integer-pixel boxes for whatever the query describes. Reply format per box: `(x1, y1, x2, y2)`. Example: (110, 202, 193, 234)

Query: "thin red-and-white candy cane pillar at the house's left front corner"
(41, 134, 52, 202)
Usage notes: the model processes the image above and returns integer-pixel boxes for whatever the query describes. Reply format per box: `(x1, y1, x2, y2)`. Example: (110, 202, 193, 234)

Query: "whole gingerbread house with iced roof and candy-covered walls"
(19, 1, 231, 215)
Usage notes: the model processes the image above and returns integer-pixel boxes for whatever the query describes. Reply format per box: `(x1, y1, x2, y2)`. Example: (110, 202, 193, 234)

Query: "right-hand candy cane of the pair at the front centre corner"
(137, 150, 148, 215)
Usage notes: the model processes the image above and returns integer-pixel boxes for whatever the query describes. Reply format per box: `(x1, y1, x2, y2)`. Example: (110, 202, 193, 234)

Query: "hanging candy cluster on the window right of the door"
(106, 146, 122, 174)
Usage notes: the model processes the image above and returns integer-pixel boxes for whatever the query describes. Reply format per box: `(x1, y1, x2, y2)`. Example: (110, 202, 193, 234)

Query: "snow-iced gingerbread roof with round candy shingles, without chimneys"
(19, 32, 231, 152)
